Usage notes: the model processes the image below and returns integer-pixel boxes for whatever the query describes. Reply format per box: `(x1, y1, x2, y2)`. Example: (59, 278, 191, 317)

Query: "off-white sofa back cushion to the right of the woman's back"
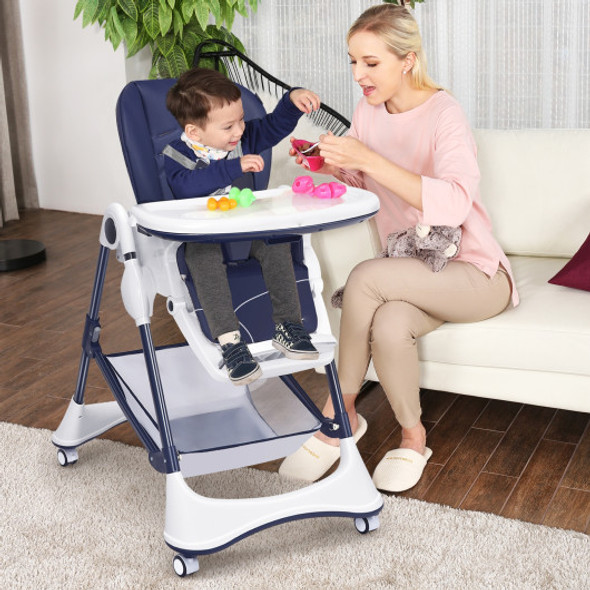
(474, 129, 590, 258)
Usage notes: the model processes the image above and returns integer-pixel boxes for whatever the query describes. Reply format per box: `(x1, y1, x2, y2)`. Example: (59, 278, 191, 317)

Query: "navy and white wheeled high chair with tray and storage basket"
(52, 80, 383, 576)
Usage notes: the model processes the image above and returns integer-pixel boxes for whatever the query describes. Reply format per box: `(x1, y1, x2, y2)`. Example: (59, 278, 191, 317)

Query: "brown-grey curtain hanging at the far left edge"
(0, 0, 39, 227)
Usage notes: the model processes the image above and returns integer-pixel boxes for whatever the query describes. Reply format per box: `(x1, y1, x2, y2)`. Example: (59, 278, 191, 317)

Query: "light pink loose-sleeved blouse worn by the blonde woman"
(341, 90, 518, 306)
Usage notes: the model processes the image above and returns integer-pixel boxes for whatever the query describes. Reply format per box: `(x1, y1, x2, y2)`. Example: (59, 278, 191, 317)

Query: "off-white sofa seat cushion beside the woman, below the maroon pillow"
(418, 256, 590, 380)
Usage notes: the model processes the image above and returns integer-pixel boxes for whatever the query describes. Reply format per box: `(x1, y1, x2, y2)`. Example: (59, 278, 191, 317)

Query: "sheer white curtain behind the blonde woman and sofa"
(234, 0, 590, 129)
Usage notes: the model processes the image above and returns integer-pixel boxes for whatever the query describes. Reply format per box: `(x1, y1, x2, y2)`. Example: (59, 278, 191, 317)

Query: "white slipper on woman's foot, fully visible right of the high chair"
(373, 447, 432, 492)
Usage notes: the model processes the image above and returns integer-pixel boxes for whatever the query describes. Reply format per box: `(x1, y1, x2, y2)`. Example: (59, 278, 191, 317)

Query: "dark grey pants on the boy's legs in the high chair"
(185, 240, 301, 339)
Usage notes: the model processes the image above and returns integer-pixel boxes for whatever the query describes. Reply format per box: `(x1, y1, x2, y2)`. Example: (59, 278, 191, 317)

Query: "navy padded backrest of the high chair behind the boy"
(117, 78, 271, 203)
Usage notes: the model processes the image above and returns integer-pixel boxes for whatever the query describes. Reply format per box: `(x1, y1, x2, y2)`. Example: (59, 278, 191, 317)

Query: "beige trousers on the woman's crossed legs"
(338, 258, 511, 428)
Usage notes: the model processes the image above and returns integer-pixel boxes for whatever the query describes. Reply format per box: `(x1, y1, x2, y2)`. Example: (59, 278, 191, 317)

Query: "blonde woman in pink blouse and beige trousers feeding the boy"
(280, 4, 518, 492)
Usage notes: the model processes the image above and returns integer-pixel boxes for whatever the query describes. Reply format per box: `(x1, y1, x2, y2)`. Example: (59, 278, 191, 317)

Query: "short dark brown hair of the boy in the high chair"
(166, 68, 242, 129)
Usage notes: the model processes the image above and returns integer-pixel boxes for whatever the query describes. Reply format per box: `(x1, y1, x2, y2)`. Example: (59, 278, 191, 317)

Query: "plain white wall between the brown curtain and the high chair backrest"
(19, 0, 135, 214)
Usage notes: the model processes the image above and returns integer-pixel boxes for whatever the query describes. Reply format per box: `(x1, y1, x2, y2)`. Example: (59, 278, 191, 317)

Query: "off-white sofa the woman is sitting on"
(306, 129, 590, 412)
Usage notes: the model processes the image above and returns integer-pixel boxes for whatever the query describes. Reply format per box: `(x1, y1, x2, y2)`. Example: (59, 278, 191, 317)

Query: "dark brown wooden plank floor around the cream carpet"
(0, 210, 590, 533)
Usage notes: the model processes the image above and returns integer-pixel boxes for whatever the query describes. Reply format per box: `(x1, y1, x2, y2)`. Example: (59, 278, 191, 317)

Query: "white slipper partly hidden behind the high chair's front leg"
(279, 414, 367, 482)
